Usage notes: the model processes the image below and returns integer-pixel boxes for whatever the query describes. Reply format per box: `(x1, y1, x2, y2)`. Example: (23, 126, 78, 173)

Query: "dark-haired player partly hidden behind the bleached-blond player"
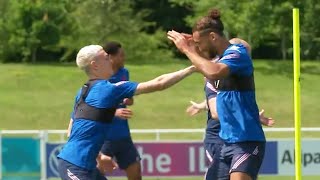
(99, 42, 141, 180)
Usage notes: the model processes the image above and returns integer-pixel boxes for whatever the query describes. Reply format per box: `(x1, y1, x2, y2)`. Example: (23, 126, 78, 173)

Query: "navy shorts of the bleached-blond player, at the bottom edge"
(58, 158, 107, 180)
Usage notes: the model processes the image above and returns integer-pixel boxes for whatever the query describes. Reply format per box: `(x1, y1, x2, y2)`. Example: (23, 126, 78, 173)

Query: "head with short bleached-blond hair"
(76, 45, 113, 79)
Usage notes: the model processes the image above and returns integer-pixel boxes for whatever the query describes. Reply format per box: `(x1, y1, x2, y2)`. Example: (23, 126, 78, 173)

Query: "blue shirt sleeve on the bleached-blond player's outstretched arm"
(113, 81, 138, 100)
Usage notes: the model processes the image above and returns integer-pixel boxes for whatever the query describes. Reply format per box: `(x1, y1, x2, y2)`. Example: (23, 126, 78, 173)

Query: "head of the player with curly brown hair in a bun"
(192, 9, 225, 58)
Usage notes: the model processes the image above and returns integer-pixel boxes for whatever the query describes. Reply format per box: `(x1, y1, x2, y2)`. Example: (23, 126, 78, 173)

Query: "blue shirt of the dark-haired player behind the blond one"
(107, 68, 130, 140)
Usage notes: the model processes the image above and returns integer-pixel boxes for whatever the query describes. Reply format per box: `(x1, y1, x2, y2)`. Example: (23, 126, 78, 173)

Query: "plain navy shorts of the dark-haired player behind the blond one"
(101, 138, 141, 169)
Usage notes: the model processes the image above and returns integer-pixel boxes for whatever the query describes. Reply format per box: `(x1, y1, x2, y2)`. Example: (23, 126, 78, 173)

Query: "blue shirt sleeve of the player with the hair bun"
(219, 51, 251, 74)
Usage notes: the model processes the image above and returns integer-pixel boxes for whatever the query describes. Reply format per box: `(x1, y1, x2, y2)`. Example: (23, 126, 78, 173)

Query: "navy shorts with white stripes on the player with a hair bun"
(218, 142, 265, 180)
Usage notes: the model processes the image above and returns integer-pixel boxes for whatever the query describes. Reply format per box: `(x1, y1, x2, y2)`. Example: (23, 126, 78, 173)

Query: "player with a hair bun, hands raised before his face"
(167, 9, 266, 180)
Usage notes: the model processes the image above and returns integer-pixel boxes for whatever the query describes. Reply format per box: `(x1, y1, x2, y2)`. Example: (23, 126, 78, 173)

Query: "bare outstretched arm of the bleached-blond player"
(135, 66, 195, 95)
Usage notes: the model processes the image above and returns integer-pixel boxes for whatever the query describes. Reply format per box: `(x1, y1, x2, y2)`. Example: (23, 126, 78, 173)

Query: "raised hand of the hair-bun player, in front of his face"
(167, 30, 195, 53)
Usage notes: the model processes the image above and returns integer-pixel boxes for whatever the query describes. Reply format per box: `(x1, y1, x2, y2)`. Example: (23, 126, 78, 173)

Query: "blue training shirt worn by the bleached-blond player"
(58, 80, 138, 170)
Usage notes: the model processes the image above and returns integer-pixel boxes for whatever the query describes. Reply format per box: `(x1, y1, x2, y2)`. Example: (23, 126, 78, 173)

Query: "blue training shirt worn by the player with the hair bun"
(216, 44, 265, 143)
